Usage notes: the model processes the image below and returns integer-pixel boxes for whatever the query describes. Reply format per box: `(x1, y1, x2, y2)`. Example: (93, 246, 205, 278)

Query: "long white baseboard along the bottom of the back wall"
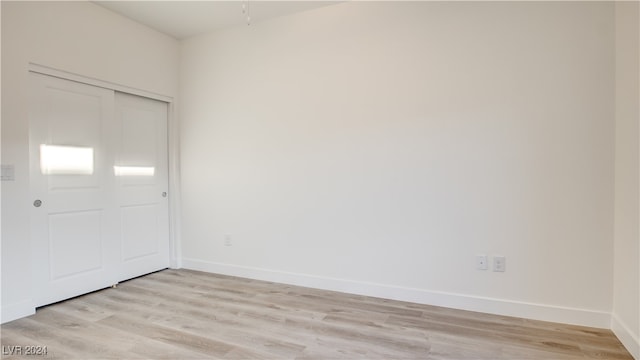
(182, 259, 611, 329)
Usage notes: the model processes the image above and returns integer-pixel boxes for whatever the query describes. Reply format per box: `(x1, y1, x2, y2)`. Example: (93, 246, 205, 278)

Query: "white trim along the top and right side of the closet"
(28, 63, 182, 269)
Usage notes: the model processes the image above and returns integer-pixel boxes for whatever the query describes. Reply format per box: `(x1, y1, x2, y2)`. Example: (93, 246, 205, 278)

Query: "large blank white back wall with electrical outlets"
(180, 2, 615, 326)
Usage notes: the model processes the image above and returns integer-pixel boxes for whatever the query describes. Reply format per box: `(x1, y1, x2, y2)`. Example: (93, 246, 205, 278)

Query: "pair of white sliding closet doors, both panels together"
(29, 73, 169, 306)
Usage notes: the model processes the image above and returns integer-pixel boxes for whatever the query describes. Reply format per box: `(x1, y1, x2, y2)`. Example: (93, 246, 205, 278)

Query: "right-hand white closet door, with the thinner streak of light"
(114, 93, 169, 280)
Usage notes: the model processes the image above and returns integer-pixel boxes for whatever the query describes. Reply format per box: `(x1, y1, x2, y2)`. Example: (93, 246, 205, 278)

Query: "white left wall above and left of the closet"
(1, 1, 178, 321)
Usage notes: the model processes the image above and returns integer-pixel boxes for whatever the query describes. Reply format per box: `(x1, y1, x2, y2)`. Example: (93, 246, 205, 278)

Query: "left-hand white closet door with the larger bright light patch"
(29, 74, 119, 306)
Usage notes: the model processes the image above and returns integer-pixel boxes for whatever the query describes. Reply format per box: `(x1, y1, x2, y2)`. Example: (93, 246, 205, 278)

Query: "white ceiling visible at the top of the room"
(92, 0, 338, 39)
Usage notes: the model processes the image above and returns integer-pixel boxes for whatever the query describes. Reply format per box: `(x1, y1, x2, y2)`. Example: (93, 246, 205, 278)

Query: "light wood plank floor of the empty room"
(1, 270, 632, 360)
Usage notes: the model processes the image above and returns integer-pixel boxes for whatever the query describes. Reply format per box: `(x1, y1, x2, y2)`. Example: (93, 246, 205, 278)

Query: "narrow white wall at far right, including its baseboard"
(611, 2, 640, 359)
